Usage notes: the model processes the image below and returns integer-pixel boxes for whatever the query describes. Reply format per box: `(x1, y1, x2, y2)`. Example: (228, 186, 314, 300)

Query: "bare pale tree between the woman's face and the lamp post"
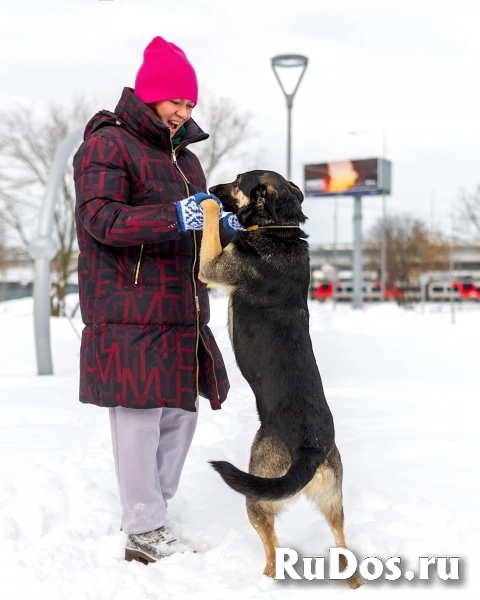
(192, 90, 255, 181)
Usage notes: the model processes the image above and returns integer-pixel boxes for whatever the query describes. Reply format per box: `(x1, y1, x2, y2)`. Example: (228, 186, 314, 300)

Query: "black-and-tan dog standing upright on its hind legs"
(199, 170, 363, 588)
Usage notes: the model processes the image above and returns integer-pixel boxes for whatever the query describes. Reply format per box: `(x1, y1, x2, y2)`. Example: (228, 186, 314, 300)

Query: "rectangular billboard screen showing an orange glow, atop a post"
(304, 158, 392, 196)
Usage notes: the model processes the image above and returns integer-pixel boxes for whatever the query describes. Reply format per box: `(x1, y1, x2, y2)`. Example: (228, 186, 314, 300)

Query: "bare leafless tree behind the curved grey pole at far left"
(0, 98, 94, 316)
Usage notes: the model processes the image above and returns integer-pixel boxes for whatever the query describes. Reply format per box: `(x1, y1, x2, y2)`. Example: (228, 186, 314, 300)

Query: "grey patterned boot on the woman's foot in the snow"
(125, 526, 194, 565)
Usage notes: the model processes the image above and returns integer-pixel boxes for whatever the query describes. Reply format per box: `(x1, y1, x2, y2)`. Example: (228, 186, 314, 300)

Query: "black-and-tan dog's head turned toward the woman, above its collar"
(209, 171, 307, 227)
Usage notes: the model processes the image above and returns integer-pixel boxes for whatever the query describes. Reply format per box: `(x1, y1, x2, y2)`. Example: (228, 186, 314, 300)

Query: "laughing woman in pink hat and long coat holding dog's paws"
(74, 37, 239, 564)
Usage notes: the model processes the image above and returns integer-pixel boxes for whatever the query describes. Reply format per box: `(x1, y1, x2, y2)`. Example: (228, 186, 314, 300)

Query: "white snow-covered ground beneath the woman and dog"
(0, 298, 480, 600)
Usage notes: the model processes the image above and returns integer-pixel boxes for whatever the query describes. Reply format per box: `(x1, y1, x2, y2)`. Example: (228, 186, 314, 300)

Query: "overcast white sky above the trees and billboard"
(0, 0, 480, 242)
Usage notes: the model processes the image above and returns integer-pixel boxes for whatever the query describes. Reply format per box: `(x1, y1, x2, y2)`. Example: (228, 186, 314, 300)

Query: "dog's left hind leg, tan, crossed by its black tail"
(247, 429, 291, 577)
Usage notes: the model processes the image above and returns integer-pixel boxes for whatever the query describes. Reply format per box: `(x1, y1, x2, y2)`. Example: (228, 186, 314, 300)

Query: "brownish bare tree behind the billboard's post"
(367, 215, 448, 287)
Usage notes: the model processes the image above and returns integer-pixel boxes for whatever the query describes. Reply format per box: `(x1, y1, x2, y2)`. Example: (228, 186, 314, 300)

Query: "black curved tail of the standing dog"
(210, 447, 327, 501)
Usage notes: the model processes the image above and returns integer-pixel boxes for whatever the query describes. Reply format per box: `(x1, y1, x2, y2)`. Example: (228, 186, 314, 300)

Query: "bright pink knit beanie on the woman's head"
(134, 36, 198, 104)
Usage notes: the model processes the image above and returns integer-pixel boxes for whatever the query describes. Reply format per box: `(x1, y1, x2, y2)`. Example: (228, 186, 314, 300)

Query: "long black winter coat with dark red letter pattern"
(73, 88, 229, 411)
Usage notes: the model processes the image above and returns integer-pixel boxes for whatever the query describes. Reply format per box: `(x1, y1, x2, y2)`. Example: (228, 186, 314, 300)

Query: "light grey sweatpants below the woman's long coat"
(109, 402, 198, 533)
